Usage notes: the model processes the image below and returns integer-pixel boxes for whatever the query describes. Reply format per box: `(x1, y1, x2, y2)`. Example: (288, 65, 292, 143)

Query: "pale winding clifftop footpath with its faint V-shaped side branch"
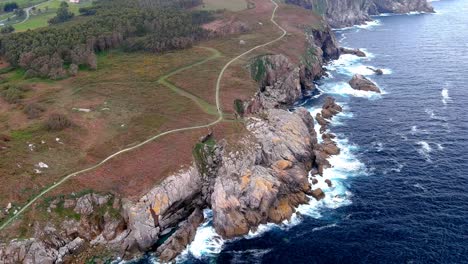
(0, 0, 287, 231)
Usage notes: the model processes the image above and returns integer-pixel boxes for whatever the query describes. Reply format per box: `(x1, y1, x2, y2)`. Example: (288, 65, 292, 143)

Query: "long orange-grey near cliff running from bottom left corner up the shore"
(0, 16, 341, 263)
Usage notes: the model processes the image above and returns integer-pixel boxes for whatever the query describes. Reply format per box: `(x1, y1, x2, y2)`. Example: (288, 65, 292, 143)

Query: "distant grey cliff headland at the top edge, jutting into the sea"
(286, 0, 434, 28)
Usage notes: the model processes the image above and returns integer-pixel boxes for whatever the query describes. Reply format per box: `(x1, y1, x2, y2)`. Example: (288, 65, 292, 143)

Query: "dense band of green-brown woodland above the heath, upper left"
(0, 0, 213, 79)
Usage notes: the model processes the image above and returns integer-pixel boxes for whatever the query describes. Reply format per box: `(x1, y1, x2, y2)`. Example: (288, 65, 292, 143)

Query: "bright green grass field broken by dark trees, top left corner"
(13, 0, 92, 31)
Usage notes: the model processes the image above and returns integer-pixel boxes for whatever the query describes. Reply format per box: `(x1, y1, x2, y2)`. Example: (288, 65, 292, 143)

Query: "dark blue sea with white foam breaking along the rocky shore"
(133, 0, 468, 264)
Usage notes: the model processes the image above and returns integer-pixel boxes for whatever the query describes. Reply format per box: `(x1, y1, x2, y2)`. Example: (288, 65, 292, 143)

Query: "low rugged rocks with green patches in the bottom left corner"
(0, 194, 127, 264)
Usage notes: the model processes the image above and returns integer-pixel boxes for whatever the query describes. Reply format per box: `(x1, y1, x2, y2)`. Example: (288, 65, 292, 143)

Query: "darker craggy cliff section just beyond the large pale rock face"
(245, 26, 340, 115)
